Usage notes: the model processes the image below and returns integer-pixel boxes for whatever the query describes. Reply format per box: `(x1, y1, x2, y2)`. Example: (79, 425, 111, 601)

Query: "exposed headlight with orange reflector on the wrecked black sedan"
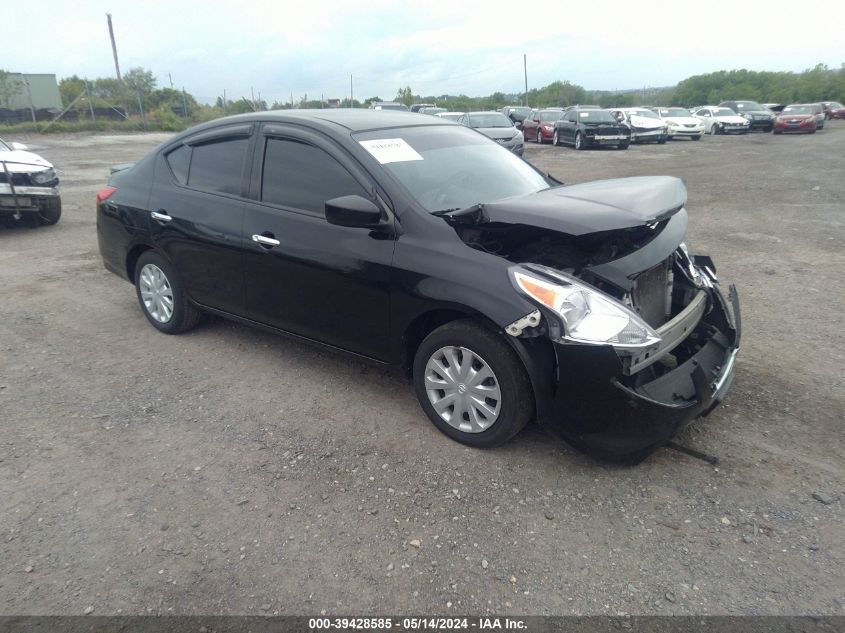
(511, 266, 660, 352)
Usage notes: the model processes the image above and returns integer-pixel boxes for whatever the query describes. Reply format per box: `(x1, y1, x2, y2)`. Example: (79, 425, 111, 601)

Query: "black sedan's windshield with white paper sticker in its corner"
(353, 125, 549, 211)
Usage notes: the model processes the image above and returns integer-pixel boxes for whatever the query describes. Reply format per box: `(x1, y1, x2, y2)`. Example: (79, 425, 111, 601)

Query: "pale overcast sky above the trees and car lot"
(8, 0, 845, 103)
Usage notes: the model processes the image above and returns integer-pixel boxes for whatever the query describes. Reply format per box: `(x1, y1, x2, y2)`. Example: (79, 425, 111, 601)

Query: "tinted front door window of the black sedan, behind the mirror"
(261, 138, 367, 216)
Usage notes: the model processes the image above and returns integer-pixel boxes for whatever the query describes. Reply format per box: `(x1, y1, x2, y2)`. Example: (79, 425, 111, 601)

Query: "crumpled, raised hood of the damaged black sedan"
(474, 176, 687, 236)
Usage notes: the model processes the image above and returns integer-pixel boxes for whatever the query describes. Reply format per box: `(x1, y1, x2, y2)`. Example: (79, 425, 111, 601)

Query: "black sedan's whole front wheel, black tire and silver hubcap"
(413, 319, 534, 448)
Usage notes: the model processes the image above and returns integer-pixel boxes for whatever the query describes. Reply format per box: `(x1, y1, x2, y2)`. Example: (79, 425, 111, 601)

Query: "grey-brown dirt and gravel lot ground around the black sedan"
(0, 122, 845, 614)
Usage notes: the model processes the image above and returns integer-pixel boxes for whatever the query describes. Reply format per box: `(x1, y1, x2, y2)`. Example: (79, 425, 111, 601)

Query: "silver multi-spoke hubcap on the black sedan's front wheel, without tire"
(425, 346, 502, 433)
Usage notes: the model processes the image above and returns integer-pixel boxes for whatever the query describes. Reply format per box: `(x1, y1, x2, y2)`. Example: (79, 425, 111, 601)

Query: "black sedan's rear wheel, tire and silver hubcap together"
(135, 251, 200, 334)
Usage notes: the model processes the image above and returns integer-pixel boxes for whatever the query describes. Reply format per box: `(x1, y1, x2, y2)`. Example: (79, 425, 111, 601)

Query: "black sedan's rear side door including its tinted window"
(148, 124, 255, 315)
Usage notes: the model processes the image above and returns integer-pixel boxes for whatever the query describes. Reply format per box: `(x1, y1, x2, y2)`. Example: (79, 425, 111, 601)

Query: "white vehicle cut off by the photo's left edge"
(0, 139, 62, 226)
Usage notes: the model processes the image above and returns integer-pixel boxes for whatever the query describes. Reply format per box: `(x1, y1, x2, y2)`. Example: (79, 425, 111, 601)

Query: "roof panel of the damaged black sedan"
(179, 108, 445, 132)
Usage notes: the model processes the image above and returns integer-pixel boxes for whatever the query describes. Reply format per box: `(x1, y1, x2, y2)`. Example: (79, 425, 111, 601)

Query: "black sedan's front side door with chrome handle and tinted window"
(243, 124, 395, 360)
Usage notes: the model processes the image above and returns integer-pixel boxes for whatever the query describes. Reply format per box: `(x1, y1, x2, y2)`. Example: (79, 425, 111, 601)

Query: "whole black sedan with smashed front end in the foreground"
(97, 110, 739, 461)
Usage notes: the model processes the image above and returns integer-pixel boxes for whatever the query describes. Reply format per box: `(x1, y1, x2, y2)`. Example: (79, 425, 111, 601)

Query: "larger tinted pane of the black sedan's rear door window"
(188, 138, 249, 196)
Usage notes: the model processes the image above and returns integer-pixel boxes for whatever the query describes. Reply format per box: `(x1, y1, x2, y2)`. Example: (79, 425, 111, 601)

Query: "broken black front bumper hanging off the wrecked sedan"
(538, 284, 740, 463)
